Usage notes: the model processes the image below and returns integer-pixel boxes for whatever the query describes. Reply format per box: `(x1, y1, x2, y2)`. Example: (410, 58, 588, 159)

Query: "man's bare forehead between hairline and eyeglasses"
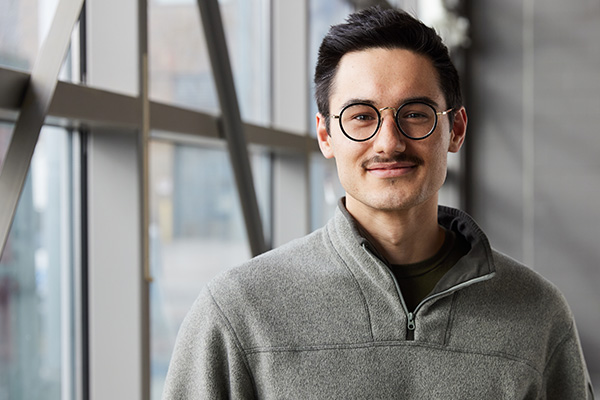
(329, 48, 444, 110)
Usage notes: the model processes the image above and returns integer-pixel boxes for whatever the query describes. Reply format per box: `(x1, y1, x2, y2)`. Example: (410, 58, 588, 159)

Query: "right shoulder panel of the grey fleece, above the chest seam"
(453, 250, 574, 364)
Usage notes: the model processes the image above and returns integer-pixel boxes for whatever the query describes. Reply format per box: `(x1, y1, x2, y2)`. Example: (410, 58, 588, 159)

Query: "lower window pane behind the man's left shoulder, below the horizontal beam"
(150, 141, 270, 399)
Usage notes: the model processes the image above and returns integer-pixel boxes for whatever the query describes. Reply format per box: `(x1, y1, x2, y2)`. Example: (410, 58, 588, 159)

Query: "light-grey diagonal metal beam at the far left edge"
(0, 0, 83, 256)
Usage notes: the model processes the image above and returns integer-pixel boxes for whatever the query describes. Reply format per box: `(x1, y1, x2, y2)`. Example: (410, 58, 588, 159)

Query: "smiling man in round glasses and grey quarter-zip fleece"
(165, 8, 593, 399)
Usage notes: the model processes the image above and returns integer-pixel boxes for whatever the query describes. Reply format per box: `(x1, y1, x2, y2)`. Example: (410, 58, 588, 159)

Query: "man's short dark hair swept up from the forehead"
(315, 7, 462, 125)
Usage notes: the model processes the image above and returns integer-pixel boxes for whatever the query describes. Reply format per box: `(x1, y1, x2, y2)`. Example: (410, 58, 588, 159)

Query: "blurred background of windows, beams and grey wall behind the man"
(0, 0, 600, 400)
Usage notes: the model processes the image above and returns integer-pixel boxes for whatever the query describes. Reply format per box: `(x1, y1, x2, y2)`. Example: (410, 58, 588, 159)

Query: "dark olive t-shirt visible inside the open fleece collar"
(390, 230, 470, 312)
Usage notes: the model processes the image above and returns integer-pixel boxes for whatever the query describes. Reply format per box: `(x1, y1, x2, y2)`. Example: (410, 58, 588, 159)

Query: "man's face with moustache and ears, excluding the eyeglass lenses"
(317, 48, 466, 217)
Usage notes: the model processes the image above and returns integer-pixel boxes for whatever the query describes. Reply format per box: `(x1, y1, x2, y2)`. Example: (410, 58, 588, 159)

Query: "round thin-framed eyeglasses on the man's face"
(332, 101, 452, 142)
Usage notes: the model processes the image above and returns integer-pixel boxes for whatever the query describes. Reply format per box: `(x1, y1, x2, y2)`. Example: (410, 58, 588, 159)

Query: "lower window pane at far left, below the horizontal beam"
(0, 128, 74, 400)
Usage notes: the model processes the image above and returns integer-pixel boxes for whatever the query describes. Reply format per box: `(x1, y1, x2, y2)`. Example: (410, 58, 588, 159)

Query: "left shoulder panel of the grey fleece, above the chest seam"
(195, 230, 370, 349)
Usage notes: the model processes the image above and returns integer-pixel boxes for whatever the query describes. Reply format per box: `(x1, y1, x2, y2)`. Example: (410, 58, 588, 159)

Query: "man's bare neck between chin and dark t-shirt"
(346, 196, 445, 264)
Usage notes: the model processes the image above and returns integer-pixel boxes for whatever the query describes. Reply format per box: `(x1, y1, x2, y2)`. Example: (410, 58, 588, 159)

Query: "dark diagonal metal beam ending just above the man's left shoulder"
(198, 0, 267, 255)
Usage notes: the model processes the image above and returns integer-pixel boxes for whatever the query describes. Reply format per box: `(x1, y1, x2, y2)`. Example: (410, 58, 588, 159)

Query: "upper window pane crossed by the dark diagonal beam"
(148, 0, 270, 124)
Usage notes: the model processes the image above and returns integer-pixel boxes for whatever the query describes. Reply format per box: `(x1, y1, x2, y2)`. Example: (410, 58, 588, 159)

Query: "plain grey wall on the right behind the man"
(465, 0, 600, 391)
